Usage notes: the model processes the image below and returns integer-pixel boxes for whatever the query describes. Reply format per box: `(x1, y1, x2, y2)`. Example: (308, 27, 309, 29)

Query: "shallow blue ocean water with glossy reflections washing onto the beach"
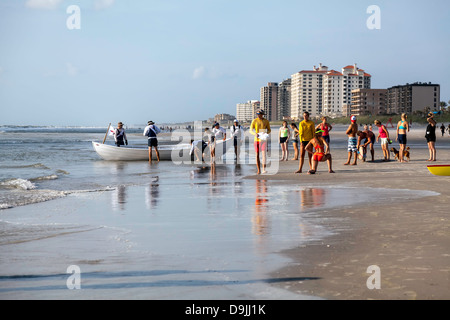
(0, 128, 442, 299)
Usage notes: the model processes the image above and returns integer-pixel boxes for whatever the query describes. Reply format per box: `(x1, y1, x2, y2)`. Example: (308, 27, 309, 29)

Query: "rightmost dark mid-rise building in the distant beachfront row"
(387, 82, 441, 114)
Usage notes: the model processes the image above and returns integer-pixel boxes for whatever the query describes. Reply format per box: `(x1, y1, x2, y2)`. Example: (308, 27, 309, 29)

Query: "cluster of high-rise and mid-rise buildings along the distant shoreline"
(236, 64, 440, 122)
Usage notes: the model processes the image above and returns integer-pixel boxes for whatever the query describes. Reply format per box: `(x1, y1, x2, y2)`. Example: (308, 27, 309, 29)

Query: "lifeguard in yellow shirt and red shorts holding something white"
(250, 110, 272, 174)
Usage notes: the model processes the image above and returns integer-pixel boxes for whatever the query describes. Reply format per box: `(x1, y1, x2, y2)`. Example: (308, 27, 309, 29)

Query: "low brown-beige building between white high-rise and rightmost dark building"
(350, 89, 388, 116)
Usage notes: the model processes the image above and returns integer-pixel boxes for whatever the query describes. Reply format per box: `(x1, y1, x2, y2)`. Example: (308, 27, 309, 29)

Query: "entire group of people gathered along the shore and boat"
(110, 110, 442, 174)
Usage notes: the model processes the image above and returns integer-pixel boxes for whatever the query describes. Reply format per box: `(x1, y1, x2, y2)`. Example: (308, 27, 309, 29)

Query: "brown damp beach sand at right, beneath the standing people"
(248, 128, 450, 300)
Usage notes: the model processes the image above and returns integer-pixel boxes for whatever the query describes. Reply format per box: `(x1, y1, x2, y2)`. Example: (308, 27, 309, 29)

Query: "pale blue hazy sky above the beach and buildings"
(0, 0, 450, 126)
